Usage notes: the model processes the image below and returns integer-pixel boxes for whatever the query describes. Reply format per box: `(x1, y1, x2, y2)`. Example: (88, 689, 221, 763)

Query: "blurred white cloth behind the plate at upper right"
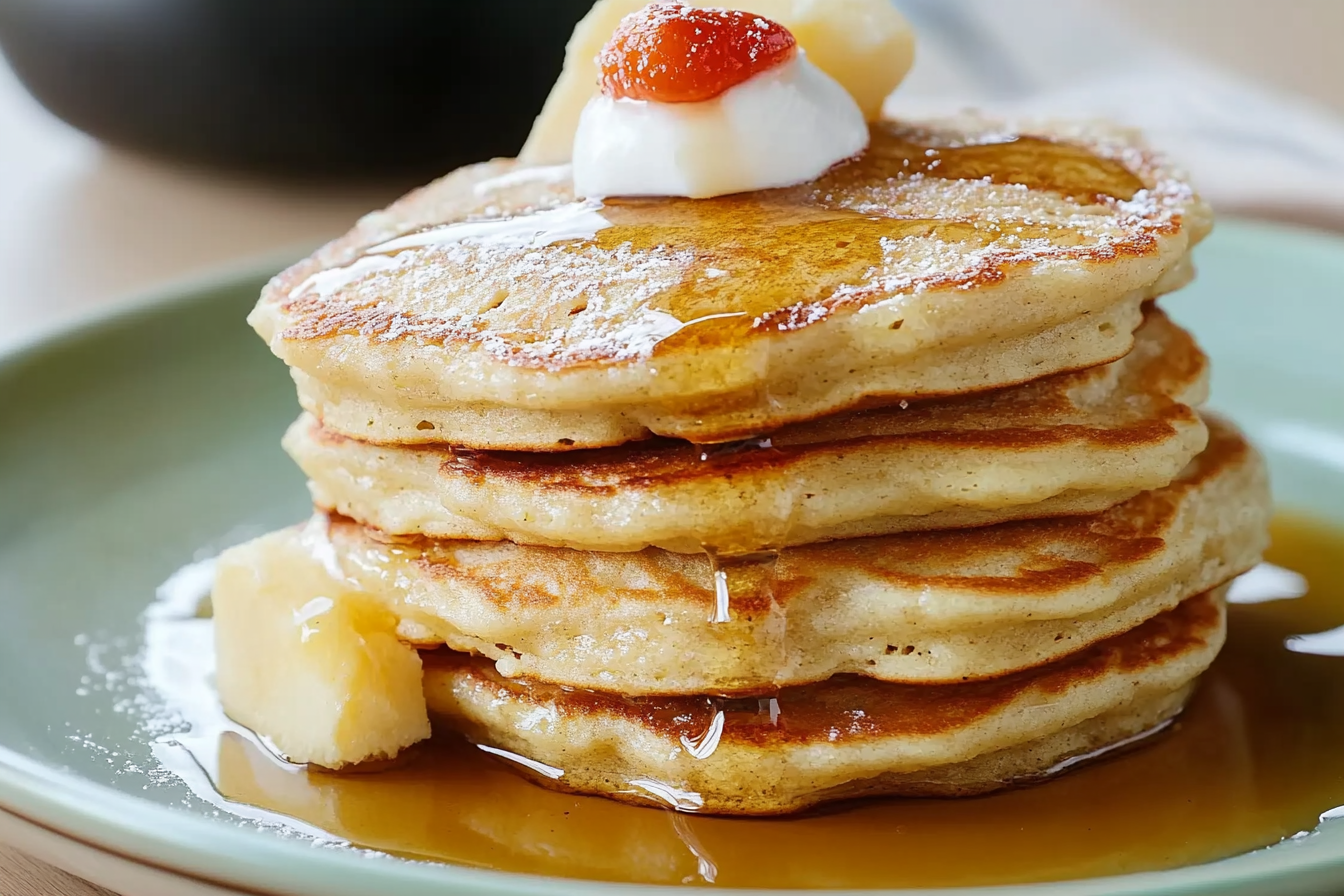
(887, 0, 1344, 230)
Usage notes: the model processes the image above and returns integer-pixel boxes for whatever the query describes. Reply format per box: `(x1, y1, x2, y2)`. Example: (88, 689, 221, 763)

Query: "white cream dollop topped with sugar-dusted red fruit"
(574, 3, 868, 199)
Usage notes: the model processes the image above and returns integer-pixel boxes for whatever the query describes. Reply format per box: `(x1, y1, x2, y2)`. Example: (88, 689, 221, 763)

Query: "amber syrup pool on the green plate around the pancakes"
(128, 517, 1344, 888)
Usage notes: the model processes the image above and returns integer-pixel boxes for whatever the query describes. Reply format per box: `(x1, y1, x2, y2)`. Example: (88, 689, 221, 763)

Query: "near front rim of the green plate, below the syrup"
(0, 747, 1344, 896)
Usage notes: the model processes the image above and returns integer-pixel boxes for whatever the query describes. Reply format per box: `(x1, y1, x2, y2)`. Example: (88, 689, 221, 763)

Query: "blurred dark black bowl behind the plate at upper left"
(0, 0, 593, 180)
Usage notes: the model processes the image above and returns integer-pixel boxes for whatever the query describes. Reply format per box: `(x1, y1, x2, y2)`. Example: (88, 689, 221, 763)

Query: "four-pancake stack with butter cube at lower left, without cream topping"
(214, 118, 1269, 814)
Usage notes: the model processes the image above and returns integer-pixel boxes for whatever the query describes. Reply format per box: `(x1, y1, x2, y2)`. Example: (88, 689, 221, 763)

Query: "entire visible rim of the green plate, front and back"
(0, 218, 1344, 896)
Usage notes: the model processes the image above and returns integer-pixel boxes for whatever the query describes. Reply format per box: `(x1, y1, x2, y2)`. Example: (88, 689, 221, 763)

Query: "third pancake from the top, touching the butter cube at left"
(306, 420, 1270, 695)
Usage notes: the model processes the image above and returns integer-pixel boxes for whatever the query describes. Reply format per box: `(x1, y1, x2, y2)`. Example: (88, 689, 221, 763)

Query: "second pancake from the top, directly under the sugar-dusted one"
(285, 308, 1208, 552)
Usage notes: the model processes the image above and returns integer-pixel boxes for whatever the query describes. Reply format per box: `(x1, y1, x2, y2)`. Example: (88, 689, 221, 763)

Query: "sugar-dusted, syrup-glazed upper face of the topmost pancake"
(266, 120, 1208, 371)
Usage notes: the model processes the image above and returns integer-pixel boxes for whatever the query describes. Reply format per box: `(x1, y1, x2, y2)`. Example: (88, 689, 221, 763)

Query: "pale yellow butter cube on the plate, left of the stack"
(212, 519, 430, 768)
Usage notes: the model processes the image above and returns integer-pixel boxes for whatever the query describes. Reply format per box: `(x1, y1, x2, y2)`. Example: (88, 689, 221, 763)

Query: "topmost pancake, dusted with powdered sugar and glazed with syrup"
(249, 118, 1210, 451)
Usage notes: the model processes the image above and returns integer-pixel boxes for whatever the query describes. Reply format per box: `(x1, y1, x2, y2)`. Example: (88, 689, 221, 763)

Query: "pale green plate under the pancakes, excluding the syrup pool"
(0, 222, 1344, 896)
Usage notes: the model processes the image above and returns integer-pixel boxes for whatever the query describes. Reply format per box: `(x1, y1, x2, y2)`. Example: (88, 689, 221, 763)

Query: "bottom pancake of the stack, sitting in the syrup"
(425, 591, 1226, 814)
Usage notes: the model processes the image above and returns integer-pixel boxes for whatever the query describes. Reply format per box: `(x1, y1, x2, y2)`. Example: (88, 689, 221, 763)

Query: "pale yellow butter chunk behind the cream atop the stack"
(519, 0, 914, 165)
